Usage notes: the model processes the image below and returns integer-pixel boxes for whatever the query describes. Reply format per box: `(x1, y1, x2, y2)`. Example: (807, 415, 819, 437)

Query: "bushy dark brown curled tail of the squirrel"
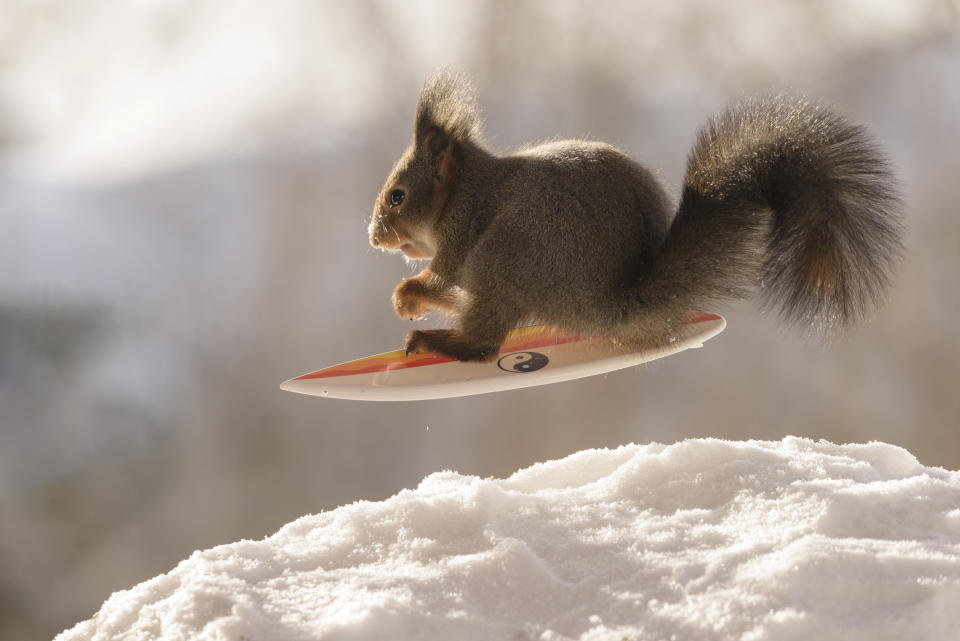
(634, 98, 902, 333)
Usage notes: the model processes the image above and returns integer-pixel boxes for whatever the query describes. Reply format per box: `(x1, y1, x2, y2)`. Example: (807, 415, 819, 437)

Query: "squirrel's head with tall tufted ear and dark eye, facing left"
(368, 69, 481, 258)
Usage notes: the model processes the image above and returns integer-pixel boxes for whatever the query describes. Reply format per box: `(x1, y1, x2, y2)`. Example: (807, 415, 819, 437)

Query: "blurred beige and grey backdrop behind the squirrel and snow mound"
(0, 0, 960, 641)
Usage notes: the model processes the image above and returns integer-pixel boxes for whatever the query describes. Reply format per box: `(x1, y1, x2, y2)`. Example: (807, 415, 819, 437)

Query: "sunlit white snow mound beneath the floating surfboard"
(57, 437, 960, 641)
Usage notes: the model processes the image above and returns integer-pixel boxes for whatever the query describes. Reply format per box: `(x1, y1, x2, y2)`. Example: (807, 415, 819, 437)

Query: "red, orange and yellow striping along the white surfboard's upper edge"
(293, 312, 721, 381)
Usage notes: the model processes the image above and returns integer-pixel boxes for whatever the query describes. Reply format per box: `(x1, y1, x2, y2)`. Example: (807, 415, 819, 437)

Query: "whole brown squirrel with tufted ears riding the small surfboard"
(368, 70, 903, 361)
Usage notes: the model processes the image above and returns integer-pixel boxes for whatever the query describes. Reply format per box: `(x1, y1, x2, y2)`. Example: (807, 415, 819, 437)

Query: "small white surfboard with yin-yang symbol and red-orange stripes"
(280, 313, 727, 401)
